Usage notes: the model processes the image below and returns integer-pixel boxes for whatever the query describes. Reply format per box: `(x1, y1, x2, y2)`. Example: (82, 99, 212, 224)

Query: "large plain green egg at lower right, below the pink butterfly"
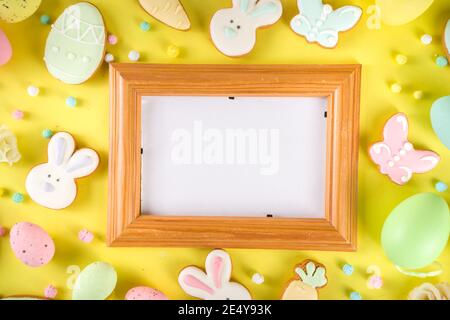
(381, 193, 450, 269)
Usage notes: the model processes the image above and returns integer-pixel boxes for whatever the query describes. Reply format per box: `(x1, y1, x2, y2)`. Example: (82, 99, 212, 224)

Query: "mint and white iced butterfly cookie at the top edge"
(291, 0, 362, 48)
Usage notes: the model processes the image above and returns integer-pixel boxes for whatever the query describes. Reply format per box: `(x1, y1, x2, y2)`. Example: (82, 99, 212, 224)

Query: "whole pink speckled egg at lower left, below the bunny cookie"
(9, 222, 55, 268)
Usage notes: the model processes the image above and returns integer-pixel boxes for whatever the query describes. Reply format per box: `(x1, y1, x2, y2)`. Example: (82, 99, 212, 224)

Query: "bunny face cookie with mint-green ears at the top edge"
(210, 0, 283, 57)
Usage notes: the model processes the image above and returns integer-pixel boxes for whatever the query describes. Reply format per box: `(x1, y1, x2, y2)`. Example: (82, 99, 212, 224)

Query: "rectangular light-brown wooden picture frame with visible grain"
(107, 64, 361, 251)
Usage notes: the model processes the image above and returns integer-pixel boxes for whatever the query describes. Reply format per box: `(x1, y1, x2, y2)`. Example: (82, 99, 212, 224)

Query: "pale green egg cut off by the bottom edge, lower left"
(72, 262, 117, 300)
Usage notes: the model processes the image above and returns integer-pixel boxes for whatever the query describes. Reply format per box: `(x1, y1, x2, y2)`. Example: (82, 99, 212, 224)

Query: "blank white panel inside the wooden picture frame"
(141, 97, 327, 218)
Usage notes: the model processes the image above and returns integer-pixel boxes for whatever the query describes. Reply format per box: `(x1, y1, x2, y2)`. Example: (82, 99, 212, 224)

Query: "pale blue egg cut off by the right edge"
(430, 96, 450, 149)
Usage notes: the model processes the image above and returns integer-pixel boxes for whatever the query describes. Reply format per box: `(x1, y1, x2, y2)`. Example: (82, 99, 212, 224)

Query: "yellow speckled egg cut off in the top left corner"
(0, 0, 41, 23)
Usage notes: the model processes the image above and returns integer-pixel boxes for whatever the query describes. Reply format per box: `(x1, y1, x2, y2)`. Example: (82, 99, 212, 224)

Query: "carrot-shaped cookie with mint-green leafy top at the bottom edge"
(282, 260, 328, 300)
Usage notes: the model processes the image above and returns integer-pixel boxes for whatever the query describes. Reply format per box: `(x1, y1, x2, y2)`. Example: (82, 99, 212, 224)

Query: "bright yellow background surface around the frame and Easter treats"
(0, 0, 450, 299)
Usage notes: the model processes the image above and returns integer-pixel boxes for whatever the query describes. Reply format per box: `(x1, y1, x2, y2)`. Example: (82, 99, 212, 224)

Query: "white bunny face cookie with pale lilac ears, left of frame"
(25, 132, 99, 210)
